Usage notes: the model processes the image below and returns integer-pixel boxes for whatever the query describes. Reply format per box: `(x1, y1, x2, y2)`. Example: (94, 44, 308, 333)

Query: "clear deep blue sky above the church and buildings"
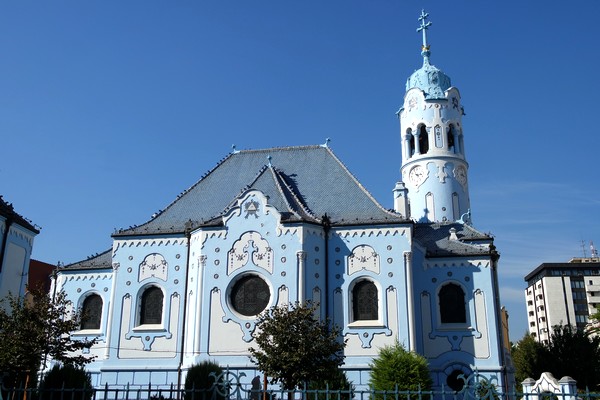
(0, 0, 600, 340)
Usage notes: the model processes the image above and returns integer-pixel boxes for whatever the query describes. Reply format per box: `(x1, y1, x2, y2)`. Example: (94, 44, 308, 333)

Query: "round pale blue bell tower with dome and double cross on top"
(394, 11, 470, 224)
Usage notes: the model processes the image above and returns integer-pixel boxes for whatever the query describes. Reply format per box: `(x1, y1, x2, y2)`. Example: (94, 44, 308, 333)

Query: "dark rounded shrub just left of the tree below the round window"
(185, 361, 226, 400)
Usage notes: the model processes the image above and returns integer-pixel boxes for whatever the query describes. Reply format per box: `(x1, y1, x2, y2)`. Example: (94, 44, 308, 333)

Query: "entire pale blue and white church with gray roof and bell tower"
(55, 13, 507, 389)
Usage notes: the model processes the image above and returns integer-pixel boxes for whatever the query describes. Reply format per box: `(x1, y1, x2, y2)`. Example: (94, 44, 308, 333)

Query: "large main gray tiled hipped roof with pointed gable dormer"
(114, 146, 405, 236)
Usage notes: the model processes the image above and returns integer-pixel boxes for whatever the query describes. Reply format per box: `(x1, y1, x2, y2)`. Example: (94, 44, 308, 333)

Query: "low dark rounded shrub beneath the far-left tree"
(40, 364, 94, 400)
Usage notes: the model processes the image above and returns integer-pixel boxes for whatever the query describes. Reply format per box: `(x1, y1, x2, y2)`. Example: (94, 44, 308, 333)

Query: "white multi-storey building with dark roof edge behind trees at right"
(525, 258, 600, 343)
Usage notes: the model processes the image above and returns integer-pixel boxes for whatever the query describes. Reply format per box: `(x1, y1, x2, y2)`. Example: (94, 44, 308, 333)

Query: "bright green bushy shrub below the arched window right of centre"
(369, 341, 433, 399)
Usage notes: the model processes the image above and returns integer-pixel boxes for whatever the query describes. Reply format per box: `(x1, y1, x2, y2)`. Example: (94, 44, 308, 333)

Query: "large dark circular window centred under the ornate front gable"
(231, 275, 271, 317)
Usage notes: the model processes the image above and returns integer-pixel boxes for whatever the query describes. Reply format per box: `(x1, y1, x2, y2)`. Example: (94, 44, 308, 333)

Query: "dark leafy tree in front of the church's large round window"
(249, 302, 345, 390)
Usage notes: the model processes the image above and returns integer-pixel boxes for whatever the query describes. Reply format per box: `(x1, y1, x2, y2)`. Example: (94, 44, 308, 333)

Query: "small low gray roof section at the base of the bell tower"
(414, 223, 496, 257)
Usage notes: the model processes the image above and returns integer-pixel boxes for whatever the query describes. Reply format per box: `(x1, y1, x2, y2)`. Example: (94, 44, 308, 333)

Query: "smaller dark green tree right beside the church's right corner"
(512, 333, 552, 383)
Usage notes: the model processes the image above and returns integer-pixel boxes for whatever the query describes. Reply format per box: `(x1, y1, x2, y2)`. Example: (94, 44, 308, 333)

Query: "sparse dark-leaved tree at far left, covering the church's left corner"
(0, 288, 95, 387)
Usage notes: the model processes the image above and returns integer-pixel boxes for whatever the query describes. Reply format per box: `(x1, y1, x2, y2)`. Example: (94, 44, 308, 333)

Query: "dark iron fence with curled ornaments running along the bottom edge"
(0, 371, 600, 400)
